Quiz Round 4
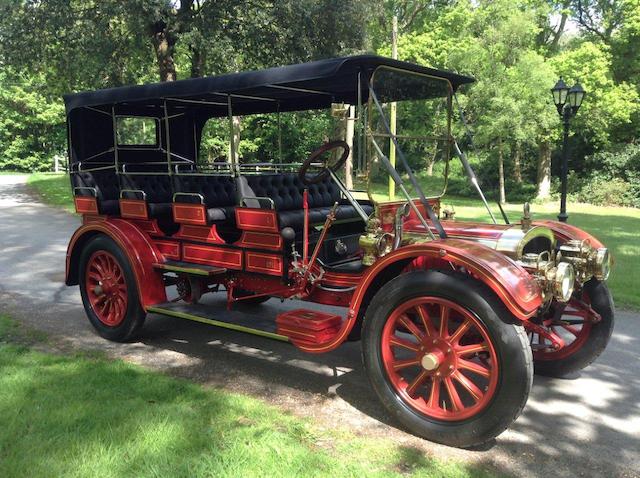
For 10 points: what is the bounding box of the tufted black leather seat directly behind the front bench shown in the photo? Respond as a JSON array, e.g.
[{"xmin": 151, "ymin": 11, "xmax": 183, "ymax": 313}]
[{"xmin": 174, "ymin": 174, "xmax": 237, "ymax": 225}]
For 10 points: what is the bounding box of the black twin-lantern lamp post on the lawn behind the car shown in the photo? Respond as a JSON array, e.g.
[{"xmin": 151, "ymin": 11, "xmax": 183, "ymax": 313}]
[{"xmin": 551, "ymin": 77, "xmax": 586, "ymax": 222}]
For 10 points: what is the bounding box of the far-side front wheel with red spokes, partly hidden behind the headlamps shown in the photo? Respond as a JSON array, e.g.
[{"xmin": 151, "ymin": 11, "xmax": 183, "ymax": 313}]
[{"xmin": 528, "ymin": 279, "xmax": 614, "ymax": 377}]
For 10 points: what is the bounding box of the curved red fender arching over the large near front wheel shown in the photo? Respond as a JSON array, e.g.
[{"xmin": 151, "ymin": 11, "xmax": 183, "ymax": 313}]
[{"xmin": 300, "ymin": 239, "xmax": 543, "ymax": 353}]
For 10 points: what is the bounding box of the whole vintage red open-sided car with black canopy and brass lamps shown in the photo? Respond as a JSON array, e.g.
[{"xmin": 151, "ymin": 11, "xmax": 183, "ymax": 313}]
[{"xmin": 65, "ymin": 56, "xmax": 614, "ymax": 447}]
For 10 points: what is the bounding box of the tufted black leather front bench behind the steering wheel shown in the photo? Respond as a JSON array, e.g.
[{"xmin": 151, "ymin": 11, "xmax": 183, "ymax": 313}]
[{"xmin": 243, "ymin": 173, "xmax": 373, "ymax": 230}]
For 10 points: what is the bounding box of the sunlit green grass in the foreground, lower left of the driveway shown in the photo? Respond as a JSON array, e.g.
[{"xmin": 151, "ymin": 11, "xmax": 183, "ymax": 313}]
[{"xmin": 0, "ymin": 316, "xmax": 491, "ymax": 477}]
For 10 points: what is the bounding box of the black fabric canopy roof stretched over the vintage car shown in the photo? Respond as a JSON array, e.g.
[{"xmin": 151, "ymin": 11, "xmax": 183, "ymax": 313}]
[{"xmin": 64, "ymin": 55, "xmax": 474, "ymax": 116}]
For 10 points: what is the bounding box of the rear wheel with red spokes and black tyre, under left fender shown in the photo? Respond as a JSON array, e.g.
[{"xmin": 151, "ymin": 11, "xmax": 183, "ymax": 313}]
[{"xmin": 78, "ymin": 235, "xmax": 146, "ymax": 342}]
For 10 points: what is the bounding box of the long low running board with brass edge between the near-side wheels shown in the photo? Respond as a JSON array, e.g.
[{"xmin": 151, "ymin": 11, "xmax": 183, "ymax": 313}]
[{"xmin": 147, "ymin": 302, "xmax": 289, "ymax": 342}]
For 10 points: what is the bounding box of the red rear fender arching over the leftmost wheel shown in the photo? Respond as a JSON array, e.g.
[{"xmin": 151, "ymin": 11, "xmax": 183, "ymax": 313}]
[{"xmin": 65, "ymin": 219, "xmax": 167, "ymax": 309}]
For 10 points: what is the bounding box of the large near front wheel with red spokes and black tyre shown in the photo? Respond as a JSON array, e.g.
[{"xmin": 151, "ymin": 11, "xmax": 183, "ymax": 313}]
[{"xmin": 363, "ymin": 271, "xmax": 533, "ymax": 447}]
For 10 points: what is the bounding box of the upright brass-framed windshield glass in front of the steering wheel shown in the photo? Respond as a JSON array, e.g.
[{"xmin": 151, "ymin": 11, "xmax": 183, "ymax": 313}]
[{"xmin": 367, "ymin": 68, "xmax": 451, "ymax": 201}]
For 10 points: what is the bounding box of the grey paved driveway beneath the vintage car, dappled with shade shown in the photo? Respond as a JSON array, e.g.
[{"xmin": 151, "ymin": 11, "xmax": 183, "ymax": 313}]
[{"xmin": 0, "ymin": 175, "xmax": 640, "ymax": 477}]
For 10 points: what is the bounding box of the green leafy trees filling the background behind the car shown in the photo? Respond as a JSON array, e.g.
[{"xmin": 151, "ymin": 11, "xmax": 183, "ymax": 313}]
[{"xmin": 0, "ymin": 0, "xmax": 640, "ymax": 204}]
